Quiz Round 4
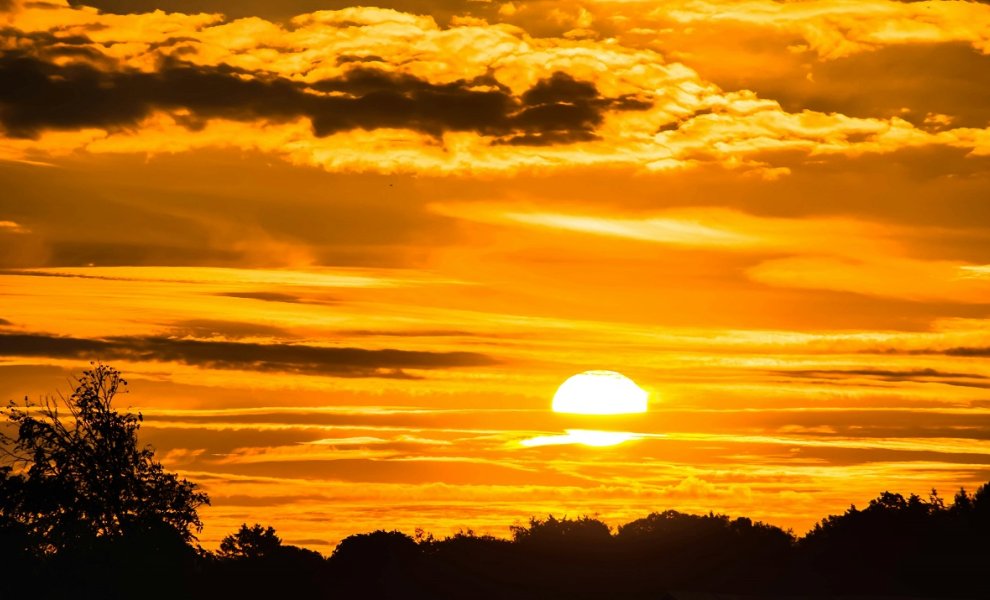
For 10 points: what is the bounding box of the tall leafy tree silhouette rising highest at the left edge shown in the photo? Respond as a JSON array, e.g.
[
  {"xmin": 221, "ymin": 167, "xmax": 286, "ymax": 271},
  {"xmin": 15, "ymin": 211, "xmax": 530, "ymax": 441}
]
[{"xmin": 0, "ymin": 364, "xmax": 209, "ymax": 554}]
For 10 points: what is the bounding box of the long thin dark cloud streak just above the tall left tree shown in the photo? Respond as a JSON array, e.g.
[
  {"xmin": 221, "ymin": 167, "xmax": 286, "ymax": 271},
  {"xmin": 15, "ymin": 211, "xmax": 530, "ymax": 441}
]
[{"xmin": 0, "ymin": 334, "xmax": 495, "ymax": 378}]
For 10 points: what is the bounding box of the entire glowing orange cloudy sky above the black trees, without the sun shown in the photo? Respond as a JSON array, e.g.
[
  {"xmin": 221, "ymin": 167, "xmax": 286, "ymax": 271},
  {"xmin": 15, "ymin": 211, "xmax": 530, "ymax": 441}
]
[{"xmin": 0, "ymin": 0, "xmax": 990, "ymax": 553}]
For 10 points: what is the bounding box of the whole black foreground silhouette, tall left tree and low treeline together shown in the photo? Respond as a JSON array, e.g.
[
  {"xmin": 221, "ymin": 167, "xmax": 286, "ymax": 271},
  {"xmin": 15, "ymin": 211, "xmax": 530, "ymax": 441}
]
[{"xmin": 0, "ymin": 365, "xmax": 990, "ymax": 600}]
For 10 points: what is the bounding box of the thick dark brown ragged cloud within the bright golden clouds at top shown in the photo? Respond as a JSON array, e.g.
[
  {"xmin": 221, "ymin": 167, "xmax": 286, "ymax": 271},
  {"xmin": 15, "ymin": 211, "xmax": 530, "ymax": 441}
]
[{"xmin": 0, "ymin": 53, "xmax": 649, "ymax": 145}]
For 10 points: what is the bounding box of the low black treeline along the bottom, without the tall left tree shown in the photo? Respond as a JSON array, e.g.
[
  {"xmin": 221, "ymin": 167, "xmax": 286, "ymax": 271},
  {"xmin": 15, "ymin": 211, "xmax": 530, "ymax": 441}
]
[{"xmin": 0, "ymin": 492, "xmax": 990, "ymax": 600}]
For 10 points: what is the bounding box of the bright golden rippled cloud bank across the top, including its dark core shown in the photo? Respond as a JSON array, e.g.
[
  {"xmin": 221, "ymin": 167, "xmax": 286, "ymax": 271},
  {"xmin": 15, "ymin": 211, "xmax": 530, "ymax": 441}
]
[{"xmin": 0, "ymin": 2, "xmax": 990, "ymax": 173}]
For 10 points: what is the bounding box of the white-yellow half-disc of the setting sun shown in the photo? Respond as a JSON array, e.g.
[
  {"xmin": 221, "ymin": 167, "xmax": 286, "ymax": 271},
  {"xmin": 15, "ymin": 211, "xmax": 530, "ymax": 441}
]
[{"xmin": 553, "ymin": 371, "xmax": 649, "ymax": 415}]
